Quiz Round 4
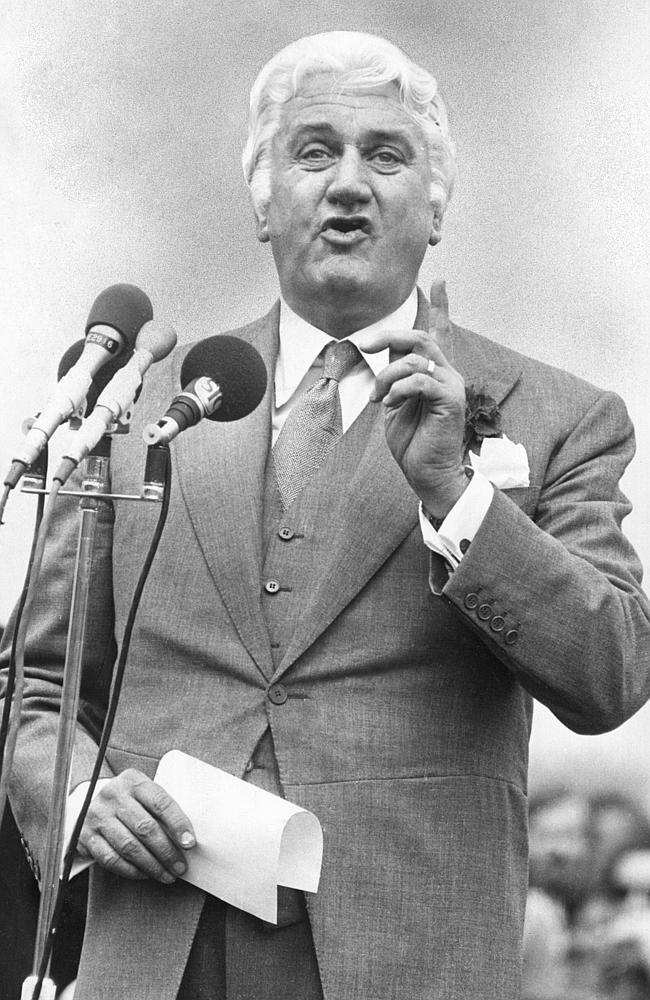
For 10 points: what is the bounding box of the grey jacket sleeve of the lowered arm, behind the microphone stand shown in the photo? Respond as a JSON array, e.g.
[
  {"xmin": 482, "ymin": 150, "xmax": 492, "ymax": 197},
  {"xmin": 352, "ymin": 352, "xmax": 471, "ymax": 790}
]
[{"xmin": 0, "ymin": 484, "xmax": 115, "ymax": 860}]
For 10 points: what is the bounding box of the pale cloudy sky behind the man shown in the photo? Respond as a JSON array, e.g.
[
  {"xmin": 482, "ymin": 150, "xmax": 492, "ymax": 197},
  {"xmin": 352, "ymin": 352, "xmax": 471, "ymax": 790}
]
[{"xmin": 0, "ymin": 0, "xmax": 650, "ymax": 805}]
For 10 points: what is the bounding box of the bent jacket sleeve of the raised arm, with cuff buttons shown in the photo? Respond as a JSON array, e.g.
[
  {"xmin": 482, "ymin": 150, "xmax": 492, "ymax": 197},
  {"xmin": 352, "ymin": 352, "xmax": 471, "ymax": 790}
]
[{"xmin": 442, "ymin": 393, "xmax": 650, "ymax": 733}]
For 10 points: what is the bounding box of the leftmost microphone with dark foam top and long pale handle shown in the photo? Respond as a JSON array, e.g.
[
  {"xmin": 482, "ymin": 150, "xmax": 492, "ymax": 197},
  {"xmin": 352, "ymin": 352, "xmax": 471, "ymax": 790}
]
[{"xmin": 5, "ymin": 284, "xmax": 153, "ymax": 488}]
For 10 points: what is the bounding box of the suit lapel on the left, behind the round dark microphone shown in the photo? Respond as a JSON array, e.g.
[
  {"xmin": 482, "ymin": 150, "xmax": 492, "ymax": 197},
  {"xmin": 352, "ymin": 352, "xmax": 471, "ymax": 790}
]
[{"xmin": 176, "ymin": 306, "xmax": 279, "ymax": 678}]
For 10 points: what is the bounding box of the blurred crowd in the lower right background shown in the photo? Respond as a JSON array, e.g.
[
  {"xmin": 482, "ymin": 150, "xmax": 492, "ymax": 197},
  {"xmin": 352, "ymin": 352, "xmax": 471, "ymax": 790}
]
[{"xmin": 522, "ymin": 789, "xmax": 650, "ymax": 1000}]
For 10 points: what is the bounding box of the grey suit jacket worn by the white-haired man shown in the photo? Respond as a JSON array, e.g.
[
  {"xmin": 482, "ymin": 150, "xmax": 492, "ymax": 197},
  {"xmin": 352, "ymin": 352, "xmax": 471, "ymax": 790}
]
[{"xmin": 1, "ymin": 292, "xmax": 650, "ymax": 1000}]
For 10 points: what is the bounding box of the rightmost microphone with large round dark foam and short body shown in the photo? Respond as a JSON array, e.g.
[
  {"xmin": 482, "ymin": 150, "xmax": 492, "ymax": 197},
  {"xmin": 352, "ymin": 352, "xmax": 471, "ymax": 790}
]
[{"xmin": 142, "ymin": 334, "xmax": 267, "ymax": 445}]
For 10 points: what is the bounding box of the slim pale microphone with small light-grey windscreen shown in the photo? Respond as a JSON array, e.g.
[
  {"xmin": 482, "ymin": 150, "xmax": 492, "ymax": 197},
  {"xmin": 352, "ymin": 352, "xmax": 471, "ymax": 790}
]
[{"xmin": 53, "ymin": 322, "xmax": 176, "ymax": 484}]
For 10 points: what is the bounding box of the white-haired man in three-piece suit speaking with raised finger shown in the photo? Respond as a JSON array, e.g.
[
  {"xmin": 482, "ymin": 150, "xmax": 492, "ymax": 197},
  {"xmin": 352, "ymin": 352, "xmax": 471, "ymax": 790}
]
[{"xmin": 3, "ymin": 32, "xmax": 649, "ymax": 1000}]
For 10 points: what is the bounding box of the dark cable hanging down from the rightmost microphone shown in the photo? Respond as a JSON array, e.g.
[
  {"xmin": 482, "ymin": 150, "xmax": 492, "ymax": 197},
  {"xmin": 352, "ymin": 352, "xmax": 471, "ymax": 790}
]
[{"xmin": 32, "ymin": 445, "xmax": 171, "ymax": 1000}]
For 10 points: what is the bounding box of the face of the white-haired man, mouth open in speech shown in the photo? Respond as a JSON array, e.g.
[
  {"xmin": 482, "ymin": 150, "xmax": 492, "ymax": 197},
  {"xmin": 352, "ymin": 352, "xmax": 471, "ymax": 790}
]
[{"xmin": 253, "ymin": 74, "xmax": 440, "ymax": 326}]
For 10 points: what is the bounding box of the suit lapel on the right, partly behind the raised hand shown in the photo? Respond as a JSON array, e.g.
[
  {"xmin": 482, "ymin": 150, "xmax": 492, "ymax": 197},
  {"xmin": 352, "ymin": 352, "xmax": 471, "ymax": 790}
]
[{"xmin": 275, "ymin": 290, "xmax": 521, "ymax": 678}]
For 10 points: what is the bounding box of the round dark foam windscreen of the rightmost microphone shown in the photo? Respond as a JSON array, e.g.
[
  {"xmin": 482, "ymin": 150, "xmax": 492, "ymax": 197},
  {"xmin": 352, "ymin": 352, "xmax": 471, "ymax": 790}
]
[{"xmin": 181, "ymin": 334, "xmax": 266, "ymax": 421}]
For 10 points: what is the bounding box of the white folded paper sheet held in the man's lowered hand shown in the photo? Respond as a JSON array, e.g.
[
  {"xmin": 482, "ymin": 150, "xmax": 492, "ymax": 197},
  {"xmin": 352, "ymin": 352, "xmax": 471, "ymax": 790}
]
[{"xmin": 155, "ymin": 750, "xmax": 323, "ymax": 923}]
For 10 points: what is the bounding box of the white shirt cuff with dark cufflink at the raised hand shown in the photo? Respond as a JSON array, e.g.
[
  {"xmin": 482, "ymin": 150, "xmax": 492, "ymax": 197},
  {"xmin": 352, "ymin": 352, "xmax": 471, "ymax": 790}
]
[{"xmin": 420, "ymin": 472, "xmax": 494, "ymax": 569}]
